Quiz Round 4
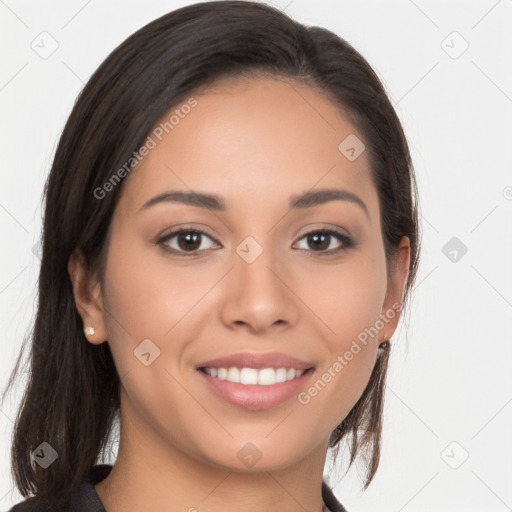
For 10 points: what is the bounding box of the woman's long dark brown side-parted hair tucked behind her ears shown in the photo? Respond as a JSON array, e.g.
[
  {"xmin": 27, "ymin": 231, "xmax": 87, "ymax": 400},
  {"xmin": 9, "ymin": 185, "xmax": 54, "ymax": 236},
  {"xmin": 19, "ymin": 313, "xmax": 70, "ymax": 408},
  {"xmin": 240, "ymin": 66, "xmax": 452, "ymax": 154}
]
[{"xmin": 4, "ymin": 1, "xmax": 419, "ymax": 506}]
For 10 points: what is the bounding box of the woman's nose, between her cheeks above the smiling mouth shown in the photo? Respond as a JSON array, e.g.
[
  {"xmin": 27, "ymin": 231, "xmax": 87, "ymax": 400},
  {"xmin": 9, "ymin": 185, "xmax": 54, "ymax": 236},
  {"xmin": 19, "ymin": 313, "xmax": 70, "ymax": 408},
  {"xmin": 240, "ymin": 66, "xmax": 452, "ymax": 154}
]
[{"xmin": 221, "ymin": 242, "xmax": 299, "ymax": 333}]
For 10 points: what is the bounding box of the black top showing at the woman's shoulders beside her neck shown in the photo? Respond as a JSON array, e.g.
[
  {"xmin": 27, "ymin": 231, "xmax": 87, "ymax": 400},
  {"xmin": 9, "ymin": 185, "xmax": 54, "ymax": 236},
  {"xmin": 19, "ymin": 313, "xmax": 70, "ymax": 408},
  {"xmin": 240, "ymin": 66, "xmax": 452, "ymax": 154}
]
[{"xmin": 8, "ymin": 464, "xmax": 347, "ymax": 512}]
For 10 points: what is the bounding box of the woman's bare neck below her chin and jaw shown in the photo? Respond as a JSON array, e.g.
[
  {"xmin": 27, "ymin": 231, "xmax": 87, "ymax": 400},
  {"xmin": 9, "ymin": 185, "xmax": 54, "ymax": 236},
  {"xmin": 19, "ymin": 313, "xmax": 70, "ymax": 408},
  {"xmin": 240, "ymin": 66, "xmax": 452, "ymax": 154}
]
[{"xmin": 95, "ymin": 410, "xmax": 327, "ymax": 512}]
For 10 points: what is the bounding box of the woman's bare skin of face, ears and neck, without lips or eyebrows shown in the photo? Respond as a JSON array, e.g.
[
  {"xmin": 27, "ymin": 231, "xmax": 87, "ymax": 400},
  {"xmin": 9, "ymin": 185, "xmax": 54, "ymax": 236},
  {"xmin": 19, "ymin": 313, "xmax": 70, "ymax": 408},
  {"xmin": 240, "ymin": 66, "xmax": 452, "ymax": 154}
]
[{"xmin": 69, "ymin": 78, "xmax": 410, "ymax": 512}]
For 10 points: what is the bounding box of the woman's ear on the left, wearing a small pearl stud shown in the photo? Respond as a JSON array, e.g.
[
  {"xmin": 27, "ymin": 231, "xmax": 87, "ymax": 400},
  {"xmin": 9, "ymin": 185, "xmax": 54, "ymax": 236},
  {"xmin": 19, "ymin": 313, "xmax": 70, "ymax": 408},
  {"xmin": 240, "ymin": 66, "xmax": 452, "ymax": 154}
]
[{"xmin": 68, "ymin": 250, "xmax": 108, "ymax": 344}]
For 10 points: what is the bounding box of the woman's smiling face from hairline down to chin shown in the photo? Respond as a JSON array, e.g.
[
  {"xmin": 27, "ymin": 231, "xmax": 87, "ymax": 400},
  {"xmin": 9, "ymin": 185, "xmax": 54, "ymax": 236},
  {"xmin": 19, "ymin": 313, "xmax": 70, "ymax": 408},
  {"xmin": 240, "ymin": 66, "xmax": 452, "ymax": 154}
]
[{"xmin": 72, "ymin": 78, "xmax": 408, "ymax": 471}]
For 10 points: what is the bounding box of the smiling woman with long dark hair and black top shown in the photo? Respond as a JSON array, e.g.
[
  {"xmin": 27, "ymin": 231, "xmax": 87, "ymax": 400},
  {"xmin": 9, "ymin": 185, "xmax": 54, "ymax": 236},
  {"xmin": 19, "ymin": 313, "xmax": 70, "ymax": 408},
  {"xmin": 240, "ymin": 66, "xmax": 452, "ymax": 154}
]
[{"xmin": 5, "ymin": 1, "xmax": 419, "ymax": 512}]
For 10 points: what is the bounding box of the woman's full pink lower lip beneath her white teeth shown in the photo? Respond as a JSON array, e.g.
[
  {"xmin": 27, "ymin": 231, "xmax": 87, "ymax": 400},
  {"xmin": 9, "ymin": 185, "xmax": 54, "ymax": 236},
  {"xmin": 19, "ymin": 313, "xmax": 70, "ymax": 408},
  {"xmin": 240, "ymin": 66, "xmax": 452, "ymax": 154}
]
[{"xmin": 197, "ymin": 369, "xmax": 313, "ymax": 411}]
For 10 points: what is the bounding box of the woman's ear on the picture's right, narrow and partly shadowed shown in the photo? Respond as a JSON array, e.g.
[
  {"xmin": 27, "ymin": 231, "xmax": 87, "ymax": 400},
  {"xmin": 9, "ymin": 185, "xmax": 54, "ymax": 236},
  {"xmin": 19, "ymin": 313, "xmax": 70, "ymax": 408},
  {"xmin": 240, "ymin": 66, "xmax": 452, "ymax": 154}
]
[{"xmin": 379, "ymin": 236, "xmax": 411, "ymax": 345}]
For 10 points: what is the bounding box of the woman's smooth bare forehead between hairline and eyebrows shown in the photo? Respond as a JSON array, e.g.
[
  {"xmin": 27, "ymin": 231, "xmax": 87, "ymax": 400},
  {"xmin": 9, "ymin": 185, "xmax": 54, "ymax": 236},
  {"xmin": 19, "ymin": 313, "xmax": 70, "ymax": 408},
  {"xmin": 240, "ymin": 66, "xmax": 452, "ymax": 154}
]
[{"xmin": 121, "ymin": 78, "xmax": 376, "ymax": 217}]
